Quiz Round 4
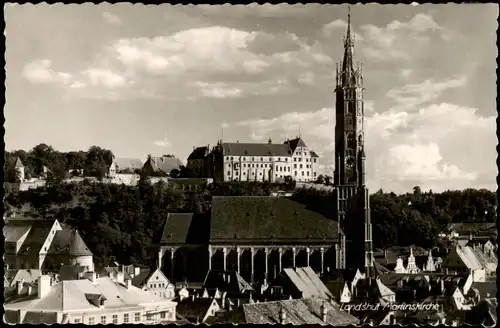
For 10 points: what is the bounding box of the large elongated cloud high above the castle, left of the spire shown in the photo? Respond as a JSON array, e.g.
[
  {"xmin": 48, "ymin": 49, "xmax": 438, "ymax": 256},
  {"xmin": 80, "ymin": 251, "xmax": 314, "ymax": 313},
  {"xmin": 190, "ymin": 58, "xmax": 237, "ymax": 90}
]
[{"xmin": 53, "ymin": 26, "xmax": 333, "ymax": 99}]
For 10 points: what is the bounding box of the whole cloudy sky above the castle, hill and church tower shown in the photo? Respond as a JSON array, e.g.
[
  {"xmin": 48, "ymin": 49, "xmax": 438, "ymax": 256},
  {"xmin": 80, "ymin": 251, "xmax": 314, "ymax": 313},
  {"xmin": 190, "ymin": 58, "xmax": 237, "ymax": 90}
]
[{"xmin": 4, "ymin": 3, "xmax": 498, "ymax": 193}]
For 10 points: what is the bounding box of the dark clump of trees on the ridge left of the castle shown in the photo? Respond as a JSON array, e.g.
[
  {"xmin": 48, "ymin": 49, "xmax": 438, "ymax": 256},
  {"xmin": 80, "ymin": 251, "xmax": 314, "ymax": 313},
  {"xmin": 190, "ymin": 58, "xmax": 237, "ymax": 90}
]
[{"xmin": 3, "ymin": 143, "xmax": 113, "ymax": 182}]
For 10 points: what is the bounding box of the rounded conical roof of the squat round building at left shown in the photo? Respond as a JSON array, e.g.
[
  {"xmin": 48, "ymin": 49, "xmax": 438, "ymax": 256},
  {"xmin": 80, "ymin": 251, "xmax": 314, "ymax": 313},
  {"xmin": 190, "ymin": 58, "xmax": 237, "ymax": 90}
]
[{"xmin": 47, "ymin": 230, "xmax": 92, "ymax": 256}]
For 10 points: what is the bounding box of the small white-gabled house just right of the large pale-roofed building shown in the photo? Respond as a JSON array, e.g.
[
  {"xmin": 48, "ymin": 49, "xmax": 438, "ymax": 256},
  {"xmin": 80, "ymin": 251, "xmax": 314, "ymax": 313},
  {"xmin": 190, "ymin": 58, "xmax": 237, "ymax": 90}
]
[{"xmin": 132, "ymin": 269, "xmax": 175, "ymax": 299}]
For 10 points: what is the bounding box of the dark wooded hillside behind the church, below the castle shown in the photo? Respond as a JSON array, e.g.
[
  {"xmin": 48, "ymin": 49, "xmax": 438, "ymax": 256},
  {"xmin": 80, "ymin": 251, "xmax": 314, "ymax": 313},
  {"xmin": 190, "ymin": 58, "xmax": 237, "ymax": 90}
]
[{"xmin": 6, "ymin": 174, "xmax": 496, "ymax": 270}]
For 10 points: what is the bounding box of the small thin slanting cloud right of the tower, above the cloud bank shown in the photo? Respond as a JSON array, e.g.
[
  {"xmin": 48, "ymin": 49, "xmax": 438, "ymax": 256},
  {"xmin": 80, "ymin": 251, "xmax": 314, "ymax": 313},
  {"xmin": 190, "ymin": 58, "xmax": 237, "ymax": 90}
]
[{"xmin": 386, "ymin": 77, "xmax": 467, "ymax": 108}]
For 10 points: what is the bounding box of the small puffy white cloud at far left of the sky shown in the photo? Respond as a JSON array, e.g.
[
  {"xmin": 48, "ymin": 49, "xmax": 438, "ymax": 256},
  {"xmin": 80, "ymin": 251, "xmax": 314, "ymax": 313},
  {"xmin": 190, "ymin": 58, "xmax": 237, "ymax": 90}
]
[{"xmin": 21, "ymin": 59, "xmax": 72, "ymax": 84}]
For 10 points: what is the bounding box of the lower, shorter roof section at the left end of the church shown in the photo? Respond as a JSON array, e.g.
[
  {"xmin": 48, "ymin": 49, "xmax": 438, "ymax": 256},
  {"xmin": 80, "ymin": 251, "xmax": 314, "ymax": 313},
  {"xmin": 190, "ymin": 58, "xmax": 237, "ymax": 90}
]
[{"xmin": 160, "ymin": 213, "xmax": 210, "ymax": 244}]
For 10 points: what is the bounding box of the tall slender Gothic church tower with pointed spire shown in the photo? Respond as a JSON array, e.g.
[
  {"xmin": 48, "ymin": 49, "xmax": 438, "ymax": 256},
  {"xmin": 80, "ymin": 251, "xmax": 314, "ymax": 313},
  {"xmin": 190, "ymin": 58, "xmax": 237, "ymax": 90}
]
[{"xmin": 334, "ymin": 7, "xmax": 373, "ymax": 276}]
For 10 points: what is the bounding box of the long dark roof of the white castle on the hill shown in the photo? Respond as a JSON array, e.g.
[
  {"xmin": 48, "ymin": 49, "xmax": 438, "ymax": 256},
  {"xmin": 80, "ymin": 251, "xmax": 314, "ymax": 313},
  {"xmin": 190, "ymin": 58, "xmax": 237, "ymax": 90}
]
[{"xmin": 222, "ymin": 142, "xmax": 291, "ymax": 157}]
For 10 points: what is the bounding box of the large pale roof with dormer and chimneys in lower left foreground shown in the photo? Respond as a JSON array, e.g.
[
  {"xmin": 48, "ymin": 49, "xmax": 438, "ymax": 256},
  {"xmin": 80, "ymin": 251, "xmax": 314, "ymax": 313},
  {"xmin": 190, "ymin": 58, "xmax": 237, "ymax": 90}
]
[{"xmin": 4, "ymin": 278, "xmax": 174, "ymax": 312}]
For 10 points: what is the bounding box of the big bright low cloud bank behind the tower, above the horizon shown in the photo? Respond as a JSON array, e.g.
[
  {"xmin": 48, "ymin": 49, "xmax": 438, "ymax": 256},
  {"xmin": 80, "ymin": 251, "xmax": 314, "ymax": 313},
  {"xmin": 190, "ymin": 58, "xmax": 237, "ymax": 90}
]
[{"xmin": 233, "ymin": 103, "xmax": 496, "ymax": 192}]
